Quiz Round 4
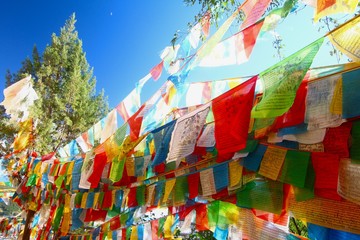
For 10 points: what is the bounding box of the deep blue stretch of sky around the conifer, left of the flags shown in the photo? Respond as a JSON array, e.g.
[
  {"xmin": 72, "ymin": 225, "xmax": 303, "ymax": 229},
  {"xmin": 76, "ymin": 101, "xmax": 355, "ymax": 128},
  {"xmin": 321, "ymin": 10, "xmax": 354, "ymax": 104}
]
[{"xmin": 0, "ymin": 0, "xmax": 198, "ymax": 107}]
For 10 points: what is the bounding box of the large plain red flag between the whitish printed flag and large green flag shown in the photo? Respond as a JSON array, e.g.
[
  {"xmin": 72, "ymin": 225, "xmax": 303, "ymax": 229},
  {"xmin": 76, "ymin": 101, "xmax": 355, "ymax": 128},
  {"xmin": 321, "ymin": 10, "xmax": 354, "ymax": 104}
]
[{"xmin": 212, "ymin": 76, "xmax": 257, "ymax": 155}]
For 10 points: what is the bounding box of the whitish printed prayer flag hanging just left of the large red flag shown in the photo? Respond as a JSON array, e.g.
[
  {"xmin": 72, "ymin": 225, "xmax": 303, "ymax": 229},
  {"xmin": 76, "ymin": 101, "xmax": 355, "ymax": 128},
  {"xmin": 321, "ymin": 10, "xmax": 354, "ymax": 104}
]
[{"xmin": 166, "ymin": 103, "xmax": 210, "ymax": 166}]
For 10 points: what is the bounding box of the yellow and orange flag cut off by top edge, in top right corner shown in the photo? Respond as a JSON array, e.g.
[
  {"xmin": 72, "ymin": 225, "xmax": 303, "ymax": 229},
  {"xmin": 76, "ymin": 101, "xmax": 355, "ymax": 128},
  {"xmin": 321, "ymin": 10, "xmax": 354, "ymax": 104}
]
[{"xmin": 314, "ymin": 0, "xmax": 358, "ymax": 22}]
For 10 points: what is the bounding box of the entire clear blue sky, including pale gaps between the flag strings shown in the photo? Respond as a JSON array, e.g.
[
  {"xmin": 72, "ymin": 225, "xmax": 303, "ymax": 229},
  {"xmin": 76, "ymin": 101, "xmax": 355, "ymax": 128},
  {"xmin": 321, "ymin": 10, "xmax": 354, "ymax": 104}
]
[{"xmin": 0, "ymin": 0, "xmax": 348, "ymax": 108}]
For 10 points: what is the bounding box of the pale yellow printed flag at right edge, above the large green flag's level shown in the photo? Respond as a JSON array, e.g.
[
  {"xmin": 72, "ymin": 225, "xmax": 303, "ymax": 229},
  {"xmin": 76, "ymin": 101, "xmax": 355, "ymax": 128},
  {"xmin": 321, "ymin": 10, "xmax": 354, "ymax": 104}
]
[{"xmin": 328, "ymin": 15, "xmax": 360, "ymax": 62}]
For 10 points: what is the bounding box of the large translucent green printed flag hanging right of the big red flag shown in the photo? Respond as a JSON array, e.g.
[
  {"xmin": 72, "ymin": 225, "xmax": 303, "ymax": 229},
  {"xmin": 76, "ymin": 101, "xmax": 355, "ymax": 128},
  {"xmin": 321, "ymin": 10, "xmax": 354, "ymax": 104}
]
[{"xmin": 251, "ymin": 38, "xmax": 324, "ymax": 118}]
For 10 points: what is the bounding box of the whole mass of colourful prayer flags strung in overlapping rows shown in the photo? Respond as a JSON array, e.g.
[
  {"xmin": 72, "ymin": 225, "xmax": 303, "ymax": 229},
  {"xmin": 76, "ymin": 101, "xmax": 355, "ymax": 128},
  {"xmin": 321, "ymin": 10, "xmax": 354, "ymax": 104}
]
[{"xmin": 0, "ymin": 0, "xmax": 360, "ymax": 239}]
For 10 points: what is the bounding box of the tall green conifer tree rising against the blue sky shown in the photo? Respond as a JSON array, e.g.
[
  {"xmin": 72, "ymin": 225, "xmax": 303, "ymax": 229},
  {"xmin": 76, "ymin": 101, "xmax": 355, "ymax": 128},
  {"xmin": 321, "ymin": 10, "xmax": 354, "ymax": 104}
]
[{"xmin": 28, "ymin": 14, "xmax": 108, "ymax": 154}]
